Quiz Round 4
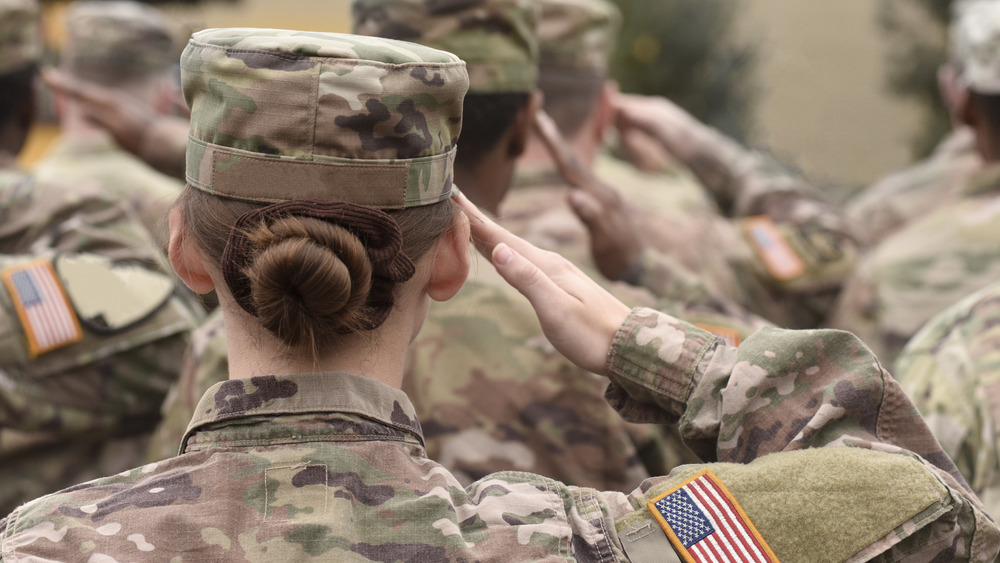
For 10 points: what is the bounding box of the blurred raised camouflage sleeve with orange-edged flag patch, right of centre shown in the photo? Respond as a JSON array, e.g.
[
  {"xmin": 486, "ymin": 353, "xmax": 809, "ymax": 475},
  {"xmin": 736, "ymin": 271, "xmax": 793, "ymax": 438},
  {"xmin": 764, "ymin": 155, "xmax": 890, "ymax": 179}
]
[{"xmin": 664, "ymin": 123, "xmax": 858, "ymax": 328}]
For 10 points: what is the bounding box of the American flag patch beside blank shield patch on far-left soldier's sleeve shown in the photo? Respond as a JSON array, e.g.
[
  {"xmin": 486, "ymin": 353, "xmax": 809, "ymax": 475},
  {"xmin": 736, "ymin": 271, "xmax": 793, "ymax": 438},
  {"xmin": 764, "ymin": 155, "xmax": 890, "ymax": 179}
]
[{"xmin": 2, "ymin": 259, "xmax": 83, "ymax": 358}]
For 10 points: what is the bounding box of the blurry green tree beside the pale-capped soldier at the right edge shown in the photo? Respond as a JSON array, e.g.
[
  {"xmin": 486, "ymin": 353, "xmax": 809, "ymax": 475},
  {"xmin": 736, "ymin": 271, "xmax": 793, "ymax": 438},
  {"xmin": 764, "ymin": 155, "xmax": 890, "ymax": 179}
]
[{"xmin": 878, "ymin": 0, "xmax": 952, "ymax": 158}]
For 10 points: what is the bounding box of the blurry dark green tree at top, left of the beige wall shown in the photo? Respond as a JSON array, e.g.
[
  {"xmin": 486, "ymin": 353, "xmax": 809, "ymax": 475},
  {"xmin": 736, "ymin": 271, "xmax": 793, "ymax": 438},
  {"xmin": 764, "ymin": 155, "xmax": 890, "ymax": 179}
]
[{"xmin": 612, "ymin": 0, "xmax": 757, "ymax": 139}]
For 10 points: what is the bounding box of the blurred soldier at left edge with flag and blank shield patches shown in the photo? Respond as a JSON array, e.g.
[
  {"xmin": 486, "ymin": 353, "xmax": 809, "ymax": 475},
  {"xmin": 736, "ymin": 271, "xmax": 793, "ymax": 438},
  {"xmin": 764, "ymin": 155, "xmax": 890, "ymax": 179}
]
[{"xmin": 0, "ymin": 0, "xmax": 197, "ymax": 511}]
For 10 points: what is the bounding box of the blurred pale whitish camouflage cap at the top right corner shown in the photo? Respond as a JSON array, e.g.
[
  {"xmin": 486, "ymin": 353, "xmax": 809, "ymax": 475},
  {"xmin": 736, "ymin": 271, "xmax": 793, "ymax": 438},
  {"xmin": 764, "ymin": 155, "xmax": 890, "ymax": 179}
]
[{"xmin": 951, "ymin": 0, "xmax": 1000, "ymax": 94}]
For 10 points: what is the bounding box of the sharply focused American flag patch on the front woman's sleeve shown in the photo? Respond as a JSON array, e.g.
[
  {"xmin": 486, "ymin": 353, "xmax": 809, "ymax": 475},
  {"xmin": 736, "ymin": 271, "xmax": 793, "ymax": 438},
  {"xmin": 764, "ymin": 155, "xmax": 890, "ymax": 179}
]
[{"xmin": 646, "ymin": 469, "xmax": 778, "ymax": 563}]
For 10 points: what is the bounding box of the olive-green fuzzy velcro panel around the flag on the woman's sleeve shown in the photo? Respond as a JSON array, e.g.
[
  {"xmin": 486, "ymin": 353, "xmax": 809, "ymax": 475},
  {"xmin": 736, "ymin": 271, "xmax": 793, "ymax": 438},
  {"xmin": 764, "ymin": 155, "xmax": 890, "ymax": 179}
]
[{"xmin": 616, "ymin": 447, "xmax": 952, "ymax": 562}]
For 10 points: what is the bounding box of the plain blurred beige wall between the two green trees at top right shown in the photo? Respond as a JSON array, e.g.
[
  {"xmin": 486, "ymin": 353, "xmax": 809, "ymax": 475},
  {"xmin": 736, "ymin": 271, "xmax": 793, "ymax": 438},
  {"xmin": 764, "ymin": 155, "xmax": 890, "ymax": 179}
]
[{"xmin": 743, "ymin": 0, "xmax": 920, "ymax": 189}]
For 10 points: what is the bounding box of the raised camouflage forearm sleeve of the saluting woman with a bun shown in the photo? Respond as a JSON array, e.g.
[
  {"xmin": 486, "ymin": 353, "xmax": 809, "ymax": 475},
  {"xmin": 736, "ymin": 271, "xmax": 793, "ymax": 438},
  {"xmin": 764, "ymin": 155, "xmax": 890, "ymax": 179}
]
[{"xmin": 607, "ymin": 309, "xmax": 967, "ymax": 488}]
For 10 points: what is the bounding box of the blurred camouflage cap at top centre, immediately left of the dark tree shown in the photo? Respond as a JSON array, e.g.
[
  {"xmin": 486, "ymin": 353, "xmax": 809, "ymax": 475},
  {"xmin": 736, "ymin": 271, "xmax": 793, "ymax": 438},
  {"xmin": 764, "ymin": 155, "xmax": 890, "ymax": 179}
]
[{"xmin": 538, "ymin": 0, "xmax": 622, "ymax": 77}]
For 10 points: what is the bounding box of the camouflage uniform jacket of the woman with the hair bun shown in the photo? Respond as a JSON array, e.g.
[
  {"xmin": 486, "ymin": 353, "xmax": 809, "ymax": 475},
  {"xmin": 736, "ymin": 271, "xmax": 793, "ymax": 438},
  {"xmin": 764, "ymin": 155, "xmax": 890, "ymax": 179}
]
[{"xmin": 0, "ymin": 309, "xmax": 1000, "ymax": 562}]
